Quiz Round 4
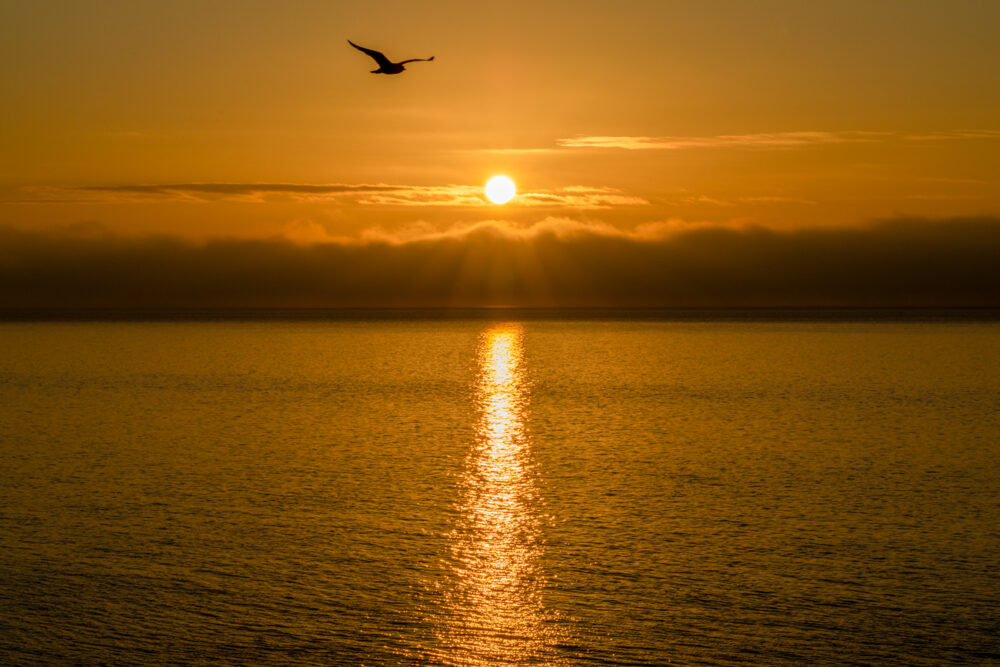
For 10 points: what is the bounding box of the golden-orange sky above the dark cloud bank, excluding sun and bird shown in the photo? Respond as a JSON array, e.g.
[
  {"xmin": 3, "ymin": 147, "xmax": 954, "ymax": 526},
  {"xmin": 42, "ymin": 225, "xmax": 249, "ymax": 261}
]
[{"xmin": 0, "ymin": 0, "xmax": 1000, "ymax": 306}]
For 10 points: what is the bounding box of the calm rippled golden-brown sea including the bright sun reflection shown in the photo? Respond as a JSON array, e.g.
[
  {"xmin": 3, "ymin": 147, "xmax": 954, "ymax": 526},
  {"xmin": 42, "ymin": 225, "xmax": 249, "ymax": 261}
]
[{"xmin": 0, "ymin": 318, "xmax": 1000, "ymax": 665}]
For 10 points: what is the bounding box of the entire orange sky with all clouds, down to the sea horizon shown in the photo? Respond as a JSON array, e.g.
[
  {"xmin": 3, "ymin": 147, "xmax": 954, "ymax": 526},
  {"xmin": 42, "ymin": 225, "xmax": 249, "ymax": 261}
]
[{"xmin": 0, "ymin": 0, "xmax": 1000, "ymax": 307}]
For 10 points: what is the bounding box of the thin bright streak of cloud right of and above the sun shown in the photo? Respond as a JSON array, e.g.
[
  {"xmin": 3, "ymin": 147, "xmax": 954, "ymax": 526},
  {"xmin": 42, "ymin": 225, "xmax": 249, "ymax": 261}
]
[{"xmin": 556, "ymin": 130, "xmax": 1000, "ymax": 150}]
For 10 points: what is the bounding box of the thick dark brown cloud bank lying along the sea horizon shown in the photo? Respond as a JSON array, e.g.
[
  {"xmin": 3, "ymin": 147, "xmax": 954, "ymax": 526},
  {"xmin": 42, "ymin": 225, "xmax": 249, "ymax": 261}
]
[{"xmin": 0, "ymin": 217, "xmax": 1000, "ymax": 309}]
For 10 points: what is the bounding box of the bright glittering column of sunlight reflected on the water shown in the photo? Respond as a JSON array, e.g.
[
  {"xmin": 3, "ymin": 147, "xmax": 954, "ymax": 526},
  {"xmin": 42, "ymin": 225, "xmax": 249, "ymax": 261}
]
[{"xmin": 441, "ymin": 324, "xmax": 557, "ymax": 664}]
